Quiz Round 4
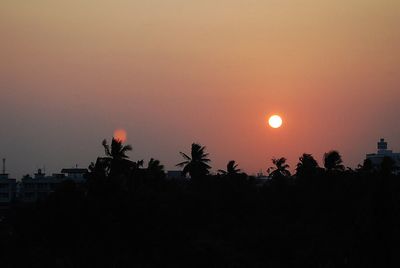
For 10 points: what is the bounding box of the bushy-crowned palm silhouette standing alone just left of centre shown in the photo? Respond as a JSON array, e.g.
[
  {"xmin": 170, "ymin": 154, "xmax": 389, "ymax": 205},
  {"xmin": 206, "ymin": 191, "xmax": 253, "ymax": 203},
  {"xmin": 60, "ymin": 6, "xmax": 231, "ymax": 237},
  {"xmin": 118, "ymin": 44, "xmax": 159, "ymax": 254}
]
[{"xmin": 176, "ymin": 143, "xmax": 211, "ymax": 179}]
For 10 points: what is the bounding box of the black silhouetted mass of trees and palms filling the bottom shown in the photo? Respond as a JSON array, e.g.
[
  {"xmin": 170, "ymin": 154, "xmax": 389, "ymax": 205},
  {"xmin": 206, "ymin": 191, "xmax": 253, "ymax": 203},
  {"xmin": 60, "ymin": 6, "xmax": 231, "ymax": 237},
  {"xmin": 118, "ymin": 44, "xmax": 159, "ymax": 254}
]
[{"xmin": 0, "ymin": 141, "xmax": 400, "ymax": 267}]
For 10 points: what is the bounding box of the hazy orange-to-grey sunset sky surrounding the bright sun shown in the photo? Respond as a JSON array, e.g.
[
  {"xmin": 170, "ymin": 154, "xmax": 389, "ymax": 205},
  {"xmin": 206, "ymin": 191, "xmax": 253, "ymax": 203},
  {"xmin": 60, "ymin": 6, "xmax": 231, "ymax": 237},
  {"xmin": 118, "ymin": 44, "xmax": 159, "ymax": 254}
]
[{"xmin": 0, "ymin": 0, "xmax": 400, "ymax": 178}]
